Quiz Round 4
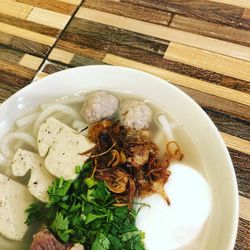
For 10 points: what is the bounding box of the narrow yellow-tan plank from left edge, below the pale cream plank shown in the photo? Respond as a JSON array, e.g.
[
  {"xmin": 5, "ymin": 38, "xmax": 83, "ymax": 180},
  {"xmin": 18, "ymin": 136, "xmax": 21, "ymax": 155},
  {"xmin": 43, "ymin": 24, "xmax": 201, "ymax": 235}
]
[{"xmin": 0, "ymin": 22, "xmax": 56, "ymax": 46}]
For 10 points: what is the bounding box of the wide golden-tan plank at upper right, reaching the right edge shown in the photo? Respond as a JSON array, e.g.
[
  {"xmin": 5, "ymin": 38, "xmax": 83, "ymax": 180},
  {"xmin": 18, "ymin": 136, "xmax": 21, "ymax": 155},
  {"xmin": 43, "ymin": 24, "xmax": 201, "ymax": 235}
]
[{"xmin": 164, "ymin": 43, "xmax": 250, "ymax": 81}]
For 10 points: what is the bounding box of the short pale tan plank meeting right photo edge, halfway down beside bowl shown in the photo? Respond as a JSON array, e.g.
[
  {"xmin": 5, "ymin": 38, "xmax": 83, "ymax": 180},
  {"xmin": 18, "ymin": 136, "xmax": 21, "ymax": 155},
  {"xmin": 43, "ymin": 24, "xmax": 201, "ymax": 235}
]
[{"xmin": 221, "ymin": 132, "xmax": 250, "ymax": 155}]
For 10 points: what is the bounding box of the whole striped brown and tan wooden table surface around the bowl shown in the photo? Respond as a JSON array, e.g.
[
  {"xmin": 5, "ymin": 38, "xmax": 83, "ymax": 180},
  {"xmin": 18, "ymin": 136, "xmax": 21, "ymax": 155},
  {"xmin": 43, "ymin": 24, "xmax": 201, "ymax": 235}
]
[{"xmin": 0, "ymin": 0, "xmax": 250, "ymax": 250}]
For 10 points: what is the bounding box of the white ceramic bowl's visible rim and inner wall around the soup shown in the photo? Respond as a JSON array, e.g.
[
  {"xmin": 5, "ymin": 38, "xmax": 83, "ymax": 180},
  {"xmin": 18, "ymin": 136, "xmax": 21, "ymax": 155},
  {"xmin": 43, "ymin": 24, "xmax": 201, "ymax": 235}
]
[{"xmin": 0, "ymin": 66, "xmax": 239, "ymax": 250}]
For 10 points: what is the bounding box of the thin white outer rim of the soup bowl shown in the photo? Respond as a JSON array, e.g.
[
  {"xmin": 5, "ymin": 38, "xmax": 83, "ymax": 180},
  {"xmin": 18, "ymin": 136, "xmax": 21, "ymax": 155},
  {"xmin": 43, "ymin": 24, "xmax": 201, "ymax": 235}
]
[{"xmin": 0, "ymin": 65, "xmax": 239, "ymax": 249}]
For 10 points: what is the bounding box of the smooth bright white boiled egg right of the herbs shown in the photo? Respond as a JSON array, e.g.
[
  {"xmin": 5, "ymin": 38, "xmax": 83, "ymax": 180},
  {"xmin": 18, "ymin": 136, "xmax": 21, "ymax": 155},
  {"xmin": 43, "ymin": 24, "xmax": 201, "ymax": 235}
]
[{"xmin": 136, "ymin": 164, "xmax": 212, "ymax": 250}]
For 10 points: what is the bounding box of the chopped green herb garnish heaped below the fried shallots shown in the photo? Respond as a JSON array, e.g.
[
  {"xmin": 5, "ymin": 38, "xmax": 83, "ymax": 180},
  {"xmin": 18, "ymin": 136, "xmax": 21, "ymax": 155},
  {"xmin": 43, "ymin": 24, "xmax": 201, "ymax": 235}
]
[{"xmin": 26, "ymin": 162, "xmax": 145, "ymax": 250}]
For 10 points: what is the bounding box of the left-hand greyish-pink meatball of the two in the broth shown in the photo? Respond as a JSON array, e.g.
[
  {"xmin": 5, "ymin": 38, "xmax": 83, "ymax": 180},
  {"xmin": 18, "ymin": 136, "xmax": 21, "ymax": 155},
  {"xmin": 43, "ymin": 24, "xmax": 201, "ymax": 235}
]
[{"xmin": 81, "ymin": 91, "xmax": 119, "ymax": 123}]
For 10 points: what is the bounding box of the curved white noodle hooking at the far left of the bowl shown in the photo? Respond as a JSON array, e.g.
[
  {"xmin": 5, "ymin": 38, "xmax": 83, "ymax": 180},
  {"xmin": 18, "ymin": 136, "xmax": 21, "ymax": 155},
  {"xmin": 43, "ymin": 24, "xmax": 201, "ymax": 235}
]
[{"xmin": 0, "ymin": 132, "xmax": 37, "ymax": 157}]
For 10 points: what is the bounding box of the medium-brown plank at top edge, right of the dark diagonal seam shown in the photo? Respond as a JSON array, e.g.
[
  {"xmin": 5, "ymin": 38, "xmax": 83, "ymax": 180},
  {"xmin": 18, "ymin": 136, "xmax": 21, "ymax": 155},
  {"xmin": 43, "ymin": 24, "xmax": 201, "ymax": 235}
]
[{"xmin": 83, "ymin": 0, "xmax": 171, "ymax": 26}]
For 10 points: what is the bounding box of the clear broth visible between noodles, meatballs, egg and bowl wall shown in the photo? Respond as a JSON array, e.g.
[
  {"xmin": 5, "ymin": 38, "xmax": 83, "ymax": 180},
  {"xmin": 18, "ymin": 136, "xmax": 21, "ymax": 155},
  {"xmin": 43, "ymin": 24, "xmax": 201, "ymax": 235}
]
[{"xmin": 0, "ymin": 92, "xmax": 207, "ymax": 250}]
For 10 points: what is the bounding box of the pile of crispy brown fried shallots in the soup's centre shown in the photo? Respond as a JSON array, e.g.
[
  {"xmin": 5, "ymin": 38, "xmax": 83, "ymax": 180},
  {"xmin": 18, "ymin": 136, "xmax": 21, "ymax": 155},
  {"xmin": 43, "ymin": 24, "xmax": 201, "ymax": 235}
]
[{"xmin": 82, "ymin": 120, "xmax": 183, "ymax": 207}]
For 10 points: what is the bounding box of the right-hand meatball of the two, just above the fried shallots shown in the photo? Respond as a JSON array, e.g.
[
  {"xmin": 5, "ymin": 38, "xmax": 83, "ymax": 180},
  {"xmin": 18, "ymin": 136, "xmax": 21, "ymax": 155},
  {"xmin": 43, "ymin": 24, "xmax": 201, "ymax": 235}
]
[{"xmin": 120, "ymin": 100, "xmax": 152, "ymax": 130}]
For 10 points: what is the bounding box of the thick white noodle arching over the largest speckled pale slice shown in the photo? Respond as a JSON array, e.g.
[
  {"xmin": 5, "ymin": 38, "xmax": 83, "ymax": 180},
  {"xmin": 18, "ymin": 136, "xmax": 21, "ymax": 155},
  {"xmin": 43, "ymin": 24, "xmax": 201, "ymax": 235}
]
[{"xmin": 34, "ymin": 104, "xmax": 81, "ymax": 133}]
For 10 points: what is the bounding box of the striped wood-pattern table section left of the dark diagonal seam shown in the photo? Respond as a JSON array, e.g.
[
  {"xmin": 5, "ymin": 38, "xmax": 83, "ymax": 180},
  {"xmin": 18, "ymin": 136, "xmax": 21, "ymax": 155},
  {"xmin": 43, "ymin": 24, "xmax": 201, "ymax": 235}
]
[{"xmin": 0, "ymin": 0, "xmax": 81, "ymax": 101}]
